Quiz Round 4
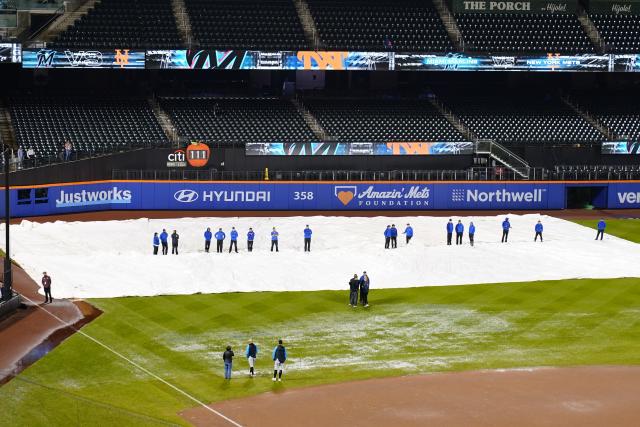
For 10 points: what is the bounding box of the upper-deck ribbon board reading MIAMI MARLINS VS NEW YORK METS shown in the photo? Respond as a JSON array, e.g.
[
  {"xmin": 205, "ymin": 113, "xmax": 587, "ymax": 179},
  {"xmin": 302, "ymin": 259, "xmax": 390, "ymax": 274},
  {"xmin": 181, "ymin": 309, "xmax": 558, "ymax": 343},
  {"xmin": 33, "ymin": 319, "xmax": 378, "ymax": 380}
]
[{"xmin": 394, "ymin": 53, "xmax": 611, "ymax": 71}]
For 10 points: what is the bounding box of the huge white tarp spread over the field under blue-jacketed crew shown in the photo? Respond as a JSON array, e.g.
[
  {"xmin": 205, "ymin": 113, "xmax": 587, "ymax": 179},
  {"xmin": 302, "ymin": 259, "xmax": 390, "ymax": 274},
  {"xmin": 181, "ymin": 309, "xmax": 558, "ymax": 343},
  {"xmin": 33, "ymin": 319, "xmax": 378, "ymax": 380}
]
[{"xmin": 0, "ymin": 214, "xmax": 640, "ymax": 298}]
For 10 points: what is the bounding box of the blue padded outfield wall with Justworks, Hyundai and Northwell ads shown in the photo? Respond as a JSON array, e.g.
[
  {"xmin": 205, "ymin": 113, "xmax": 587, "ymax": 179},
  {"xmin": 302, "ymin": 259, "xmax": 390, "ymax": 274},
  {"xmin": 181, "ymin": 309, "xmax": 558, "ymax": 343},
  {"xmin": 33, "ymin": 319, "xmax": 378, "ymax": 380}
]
[{"xmin": 7, "ymin": 181, "xmax": 640, "ymax": 217}]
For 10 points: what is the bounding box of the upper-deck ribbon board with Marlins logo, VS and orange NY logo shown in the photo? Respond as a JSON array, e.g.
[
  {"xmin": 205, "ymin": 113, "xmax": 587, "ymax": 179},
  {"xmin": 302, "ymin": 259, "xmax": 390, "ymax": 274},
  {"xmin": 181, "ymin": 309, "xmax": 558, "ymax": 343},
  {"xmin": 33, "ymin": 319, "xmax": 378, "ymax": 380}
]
[{"xmin": 22, "ymin": 49, "xmax": 145, "ymax": 69}]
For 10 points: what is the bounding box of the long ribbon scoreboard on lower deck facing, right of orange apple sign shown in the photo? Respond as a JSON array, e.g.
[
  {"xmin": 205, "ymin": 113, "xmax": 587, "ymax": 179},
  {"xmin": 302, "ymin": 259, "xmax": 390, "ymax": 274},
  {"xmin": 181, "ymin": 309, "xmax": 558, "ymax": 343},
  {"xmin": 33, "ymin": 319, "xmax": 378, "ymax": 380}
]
[{"xmin": 245, "ymin": 142, "xmax": 474, "ymax": 156}]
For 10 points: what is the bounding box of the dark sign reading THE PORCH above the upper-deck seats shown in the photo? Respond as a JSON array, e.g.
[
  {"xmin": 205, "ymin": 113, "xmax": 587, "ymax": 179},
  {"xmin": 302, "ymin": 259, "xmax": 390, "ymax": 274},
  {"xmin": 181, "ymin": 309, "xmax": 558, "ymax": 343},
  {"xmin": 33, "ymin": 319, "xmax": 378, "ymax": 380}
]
[{"xmin": 451, "ymin": 0, "xmax": 577, "ymax": 14}]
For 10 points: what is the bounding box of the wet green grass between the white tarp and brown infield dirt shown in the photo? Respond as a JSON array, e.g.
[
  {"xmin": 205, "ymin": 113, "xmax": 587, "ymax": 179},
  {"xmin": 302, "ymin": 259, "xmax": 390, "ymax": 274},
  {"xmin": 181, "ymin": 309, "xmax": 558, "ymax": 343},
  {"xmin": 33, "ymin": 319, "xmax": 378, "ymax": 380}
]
[{"xmin": 0, "ymin": 279, "xmax": 640, "ymax": 426}]
